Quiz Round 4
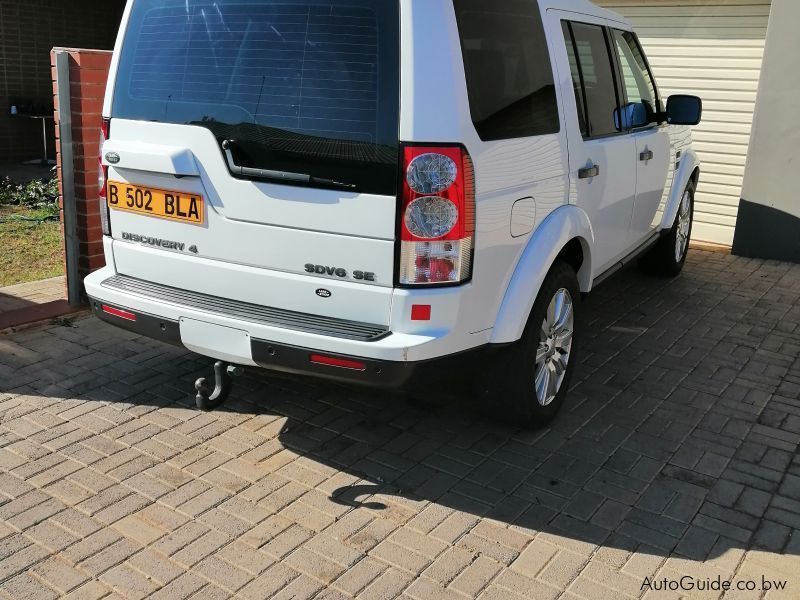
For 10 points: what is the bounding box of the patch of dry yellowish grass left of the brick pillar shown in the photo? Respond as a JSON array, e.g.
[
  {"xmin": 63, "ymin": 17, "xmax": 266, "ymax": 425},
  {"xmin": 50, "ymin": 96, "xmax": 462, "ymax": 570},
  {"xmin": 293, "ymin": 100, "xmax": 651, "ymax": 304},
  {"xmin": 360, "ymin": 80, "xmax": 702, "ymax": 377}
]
[{"xmin": 0, "ymin": 204, "xmax": 64, "ymax": 287}]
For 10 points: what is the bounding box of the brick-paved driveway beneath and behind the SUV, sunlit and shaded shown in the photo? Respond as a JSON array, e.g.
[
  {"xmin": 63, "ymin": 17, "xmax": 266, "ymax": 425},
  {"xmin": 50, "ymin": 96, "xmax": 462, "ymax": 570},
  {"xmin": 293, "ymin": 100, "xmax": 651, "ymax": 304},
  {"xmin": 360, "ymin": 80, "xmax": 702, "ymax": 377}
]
[{"xmin": 0, "ymin": 251, "xmax": 800, "ymax": 600}]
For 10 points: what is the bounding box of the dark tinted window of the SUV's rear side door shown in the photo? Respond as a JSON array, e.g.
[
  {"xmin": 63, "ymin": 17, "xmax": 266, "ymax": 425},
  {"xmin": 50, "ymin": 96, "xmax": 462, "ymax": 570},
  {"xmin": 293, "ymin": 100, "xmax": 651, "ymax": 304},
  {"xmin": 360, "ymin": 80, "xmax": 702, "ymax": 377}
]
[{"xmin": 562, "ymin": 21, "xmax": 624, "ymax": 137}]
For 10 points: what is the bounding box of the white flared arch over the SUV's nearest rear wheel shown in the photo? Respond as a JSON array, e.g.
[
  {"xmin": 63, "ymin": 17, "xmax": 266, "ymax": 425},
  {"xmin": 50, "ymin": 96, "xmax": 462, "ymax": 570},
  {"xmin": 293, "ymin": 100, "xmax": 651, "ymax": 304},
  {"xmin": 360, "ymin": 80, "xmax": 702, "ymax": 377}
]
[{"xmin": 490, "ymin": 204, "xmax": 594, "ymax": 344}]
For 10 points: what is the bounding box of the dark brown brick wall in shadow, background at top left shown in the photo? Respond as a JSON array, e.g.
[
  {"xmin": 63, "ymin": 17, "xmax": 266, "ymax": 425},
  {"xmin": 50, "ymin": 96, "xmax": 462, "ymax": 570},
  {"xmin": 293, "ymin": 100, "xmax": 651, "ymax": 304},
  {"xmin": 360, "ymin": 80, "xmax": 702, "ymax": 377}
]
[{"xmin": 0, "ymin": 0, "xmax": 125, "ymax": 164}]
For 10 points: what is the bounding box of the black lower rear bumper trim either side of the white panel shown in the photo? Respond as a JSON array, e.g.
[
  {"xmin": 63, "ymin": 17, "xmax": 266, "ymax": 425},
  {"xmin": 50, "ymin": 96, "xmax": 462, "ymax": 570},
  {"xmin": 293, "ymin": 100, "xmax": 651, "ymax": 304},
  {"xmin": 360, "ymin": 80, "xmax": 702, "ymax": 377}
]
[{"xmin": 90, "ymin": 296, "xmax": 490, "ymax": 389}]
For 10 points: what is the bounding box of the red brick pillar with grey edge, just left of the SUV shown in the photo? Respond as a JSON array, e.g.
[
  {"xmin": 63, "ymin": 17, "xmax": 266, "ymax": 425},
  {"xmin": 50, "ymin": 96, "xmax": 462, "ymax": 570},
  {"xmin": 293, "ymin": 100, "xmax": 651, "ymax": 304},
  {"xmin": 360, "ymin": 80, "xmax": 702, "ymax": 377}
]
[{"xmin": 51, "ymin": 48, "xmax": 111, "ymax": 281}]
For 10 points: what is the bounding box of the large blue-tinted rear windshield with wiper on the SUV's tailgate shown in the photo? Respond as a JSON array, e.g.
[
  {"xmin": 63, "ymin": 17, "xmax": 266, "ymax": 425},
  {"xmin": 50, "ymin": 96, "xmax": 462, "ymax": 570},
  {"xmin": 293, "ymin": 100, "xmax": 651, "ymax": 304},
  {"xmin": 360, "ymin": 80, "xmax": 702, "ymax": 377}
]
[{"xmin": 111, "ymin": 0, "xmax": 400, "ymax": 194}]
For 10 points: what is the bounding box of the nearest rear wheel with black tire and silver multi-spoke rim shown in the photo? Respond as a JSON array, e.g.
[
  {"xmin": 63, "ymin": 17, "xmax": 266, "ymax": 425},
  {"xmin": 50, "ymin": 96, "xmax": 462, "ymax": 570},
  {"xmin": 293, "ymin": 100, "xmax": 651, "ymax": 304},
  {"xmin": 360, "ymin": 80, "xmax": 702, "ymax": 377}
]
[{"xmin": 478, "ymin": 262, "xmax": 581, "ymax": 427}]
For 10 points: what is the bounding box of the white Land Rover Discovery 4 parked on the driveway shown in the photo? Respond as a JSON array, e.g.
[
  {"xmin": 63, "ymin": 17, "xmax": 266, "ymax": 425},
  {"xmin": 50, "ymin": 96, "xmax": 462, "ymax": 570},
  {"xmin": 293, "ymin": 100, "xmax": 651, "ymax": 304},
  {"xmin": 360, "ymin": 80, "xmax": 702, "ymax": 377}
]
[{"xmin": 85, "ymin": 0, "xmax": 701, "ymax": 424}]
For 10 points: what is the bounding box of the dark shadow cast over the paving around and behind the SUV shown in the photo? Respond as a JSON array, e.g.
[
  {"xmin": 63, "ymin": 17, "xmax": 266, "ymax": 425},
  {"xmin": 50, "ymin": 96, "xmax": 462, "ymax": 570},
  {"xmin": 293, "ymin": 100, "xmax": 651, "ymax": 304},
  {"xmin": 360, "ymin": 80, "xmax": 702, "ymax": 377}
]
[{"xmin": 0, "ymin": 252, "xmax": 800, "ymax": 560}]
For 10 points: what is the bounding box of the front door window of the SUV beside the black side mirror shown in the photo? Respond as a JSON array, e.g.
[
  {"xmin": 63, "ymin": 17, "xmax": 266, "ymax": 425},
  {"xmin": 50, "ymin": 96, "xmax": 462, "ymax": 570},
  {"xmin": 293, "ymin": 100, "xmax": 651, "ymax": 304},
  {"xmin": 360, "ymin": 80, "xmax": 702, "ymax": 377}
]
[{"xmin": 614, "ymin": 29, "xmax": 661, "ymax": 127}]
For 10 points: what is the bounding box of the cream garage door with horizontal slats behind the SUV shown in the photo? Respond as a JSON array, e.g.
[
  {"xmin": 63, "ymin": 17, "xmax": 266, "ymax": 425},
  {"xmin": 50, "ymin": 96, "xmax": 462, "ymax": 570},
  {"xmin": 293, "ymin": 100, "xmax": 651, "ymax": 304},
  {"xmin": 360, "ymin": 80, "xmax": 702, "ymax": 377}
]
[{"xmin": 595, "ymin": 0, "xmax": 770, "ymax": 245}]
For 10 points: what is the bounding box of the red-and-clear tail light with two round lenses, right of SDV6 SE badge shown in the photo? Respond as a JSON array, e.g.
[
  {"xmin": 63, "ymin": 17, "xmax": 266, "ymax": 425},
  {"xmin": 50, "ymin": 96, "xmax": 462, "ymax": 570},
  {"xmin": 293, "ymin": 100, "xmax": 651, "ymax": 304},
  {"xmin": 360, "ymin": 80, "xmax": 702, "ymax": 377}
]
[{"xmin": 398, "ymin": 146, "xmax": 475, "ymax": 286}]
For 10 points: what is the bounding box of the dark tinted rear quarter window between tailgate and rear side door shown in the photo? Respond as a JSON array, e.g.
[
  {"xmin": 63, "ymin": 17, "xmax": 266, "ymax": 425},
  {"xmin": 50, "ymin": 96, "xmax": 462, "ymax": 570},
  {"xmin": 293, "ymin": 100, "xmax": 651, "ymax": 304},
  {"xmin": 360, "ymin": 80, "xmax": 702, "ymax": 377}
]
[{"xmin": 454, "ymin": 0, "xmax": 560, "ymax": 140}]
